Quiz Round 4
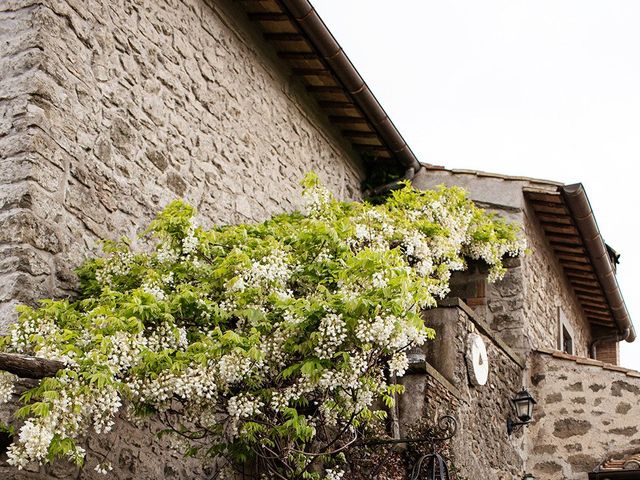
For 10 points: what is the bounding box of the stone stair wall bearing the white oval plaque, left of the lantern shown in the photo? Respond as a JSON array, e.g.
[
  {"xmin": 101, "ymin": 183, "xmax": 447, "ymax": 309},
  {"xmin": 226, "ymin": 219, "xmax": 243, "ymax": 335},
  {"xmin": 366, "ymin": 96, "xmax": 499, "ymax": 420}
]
[{"xmin": 399, "ymin": 300, "xmax": 524, "ymax": 480}]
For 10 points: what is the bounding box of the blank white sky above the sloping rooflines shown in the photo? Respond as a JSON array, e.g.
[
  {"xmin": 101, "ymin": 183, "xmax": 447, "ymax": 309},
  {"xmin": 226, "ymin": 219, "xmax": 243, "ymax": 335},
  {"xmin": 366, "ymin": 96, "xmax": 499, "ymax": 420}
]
[{"xmin": 312, "ymin": 0, "xmax": 640, "ymax": 370}]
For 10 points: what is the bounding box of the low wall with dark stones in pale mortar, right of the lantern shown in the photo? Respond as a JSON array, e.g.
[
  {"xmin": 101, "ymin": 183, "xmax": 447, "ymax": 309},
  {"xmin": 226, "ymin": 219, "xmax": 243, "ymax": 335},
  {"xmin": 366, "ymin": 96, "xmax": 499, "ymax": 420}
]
[{"xmin": 527, "ymin": 350, "xmax": 640, "ymax": 480}]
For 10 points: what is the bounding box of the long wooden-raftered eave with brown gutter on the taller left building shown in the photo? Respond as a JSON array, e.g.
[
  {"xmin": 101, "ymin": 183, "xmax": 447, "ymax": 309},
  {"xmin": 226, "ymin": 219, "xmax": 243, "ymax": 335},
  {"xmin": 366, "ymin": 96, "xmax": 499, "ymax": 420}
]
[{"xmin": 239, "ymin": 0, "xmax": 422, "ymax": 172}]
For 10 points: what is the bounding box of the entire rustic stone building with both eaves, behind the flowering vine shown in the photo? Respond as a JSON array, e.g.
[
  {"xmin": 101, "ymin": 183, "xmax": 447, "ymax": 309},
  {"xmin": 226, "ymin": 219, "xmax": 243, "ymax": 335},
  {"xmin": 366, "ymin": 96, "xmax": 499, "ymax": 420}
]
[{"xmin": 0, "ymin": 0, "xmax": 640, "ymax": 480}]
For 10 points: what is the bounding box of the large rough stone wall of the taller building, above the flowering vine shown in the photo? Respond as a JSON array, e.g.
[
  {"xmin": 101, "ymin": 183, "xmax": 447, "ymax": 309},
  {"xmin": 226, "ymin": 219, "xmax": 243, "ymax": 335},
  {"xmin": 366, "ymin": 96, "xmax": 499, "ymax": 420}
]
[{"xmin": 0, "ymin": 0, "xmax": 363, "ymax": 327}]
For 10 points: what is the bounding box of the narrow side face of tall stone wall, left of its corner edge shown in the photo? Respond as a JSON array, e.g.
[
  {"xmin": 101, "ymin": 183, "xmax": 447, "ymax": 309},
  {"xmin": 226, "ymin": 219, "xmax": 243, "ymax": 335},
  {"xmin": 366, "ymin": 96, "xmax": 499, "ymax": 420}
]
[{"xmin": 0, "ymin": 0, "xmax": 51, "ymax": 334}]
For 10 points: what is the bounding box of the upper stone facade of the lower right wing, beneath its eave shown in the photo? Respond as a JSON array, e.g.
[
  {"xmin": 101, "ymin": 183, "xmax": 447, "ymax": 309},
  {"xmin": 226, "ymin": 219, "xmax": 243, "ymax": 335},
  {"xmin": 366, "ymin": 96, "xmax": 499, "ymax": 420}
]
[{"xmin": 414, "ymin": 170, "xmax": 591, "ymax": 356}]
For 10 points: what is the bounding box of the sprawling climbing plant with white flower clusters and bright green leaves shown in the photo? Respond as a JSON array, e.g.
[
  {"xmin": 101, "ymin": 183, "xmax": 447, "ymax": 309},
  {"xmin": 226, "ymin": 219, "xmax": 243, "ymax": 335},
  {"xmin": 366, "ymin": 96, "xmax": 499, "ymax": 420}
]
[{"xmin": 0, "ymin": 175, "xmax": 523, "ymax": 479}]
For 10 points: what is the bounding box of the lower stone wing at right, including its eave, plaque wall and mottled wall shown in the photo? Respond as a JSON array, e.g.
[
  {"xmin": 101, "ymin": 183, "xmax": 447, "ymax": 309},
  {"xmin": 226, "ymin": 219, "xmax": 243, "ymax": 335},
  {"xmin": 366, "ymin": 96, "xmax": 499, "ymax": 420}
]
[{"xmin": 400, "ymin": 166, "xmax": 640, "ymax": 480}]
